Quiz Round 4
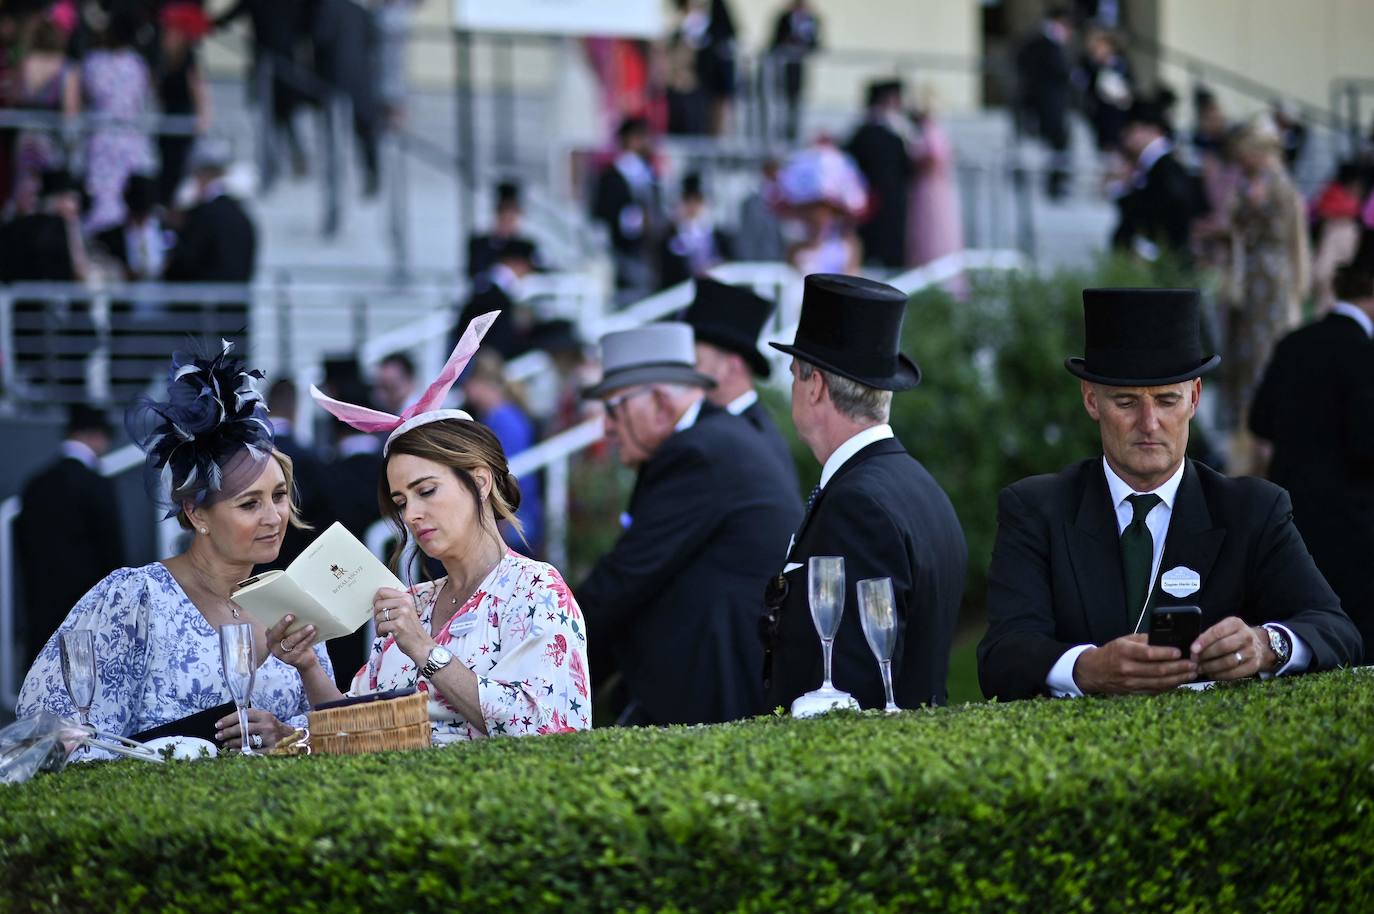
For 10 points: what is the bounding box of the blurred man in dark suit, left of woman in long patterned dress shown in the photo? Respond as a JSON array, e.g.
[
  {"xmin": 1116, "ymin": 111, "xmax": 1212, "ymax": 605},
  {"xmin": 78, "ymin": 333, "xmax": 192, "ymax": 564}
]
[{"xmin": 1112, "ymin": 102, "xmax": 1201, "ymax": 261}]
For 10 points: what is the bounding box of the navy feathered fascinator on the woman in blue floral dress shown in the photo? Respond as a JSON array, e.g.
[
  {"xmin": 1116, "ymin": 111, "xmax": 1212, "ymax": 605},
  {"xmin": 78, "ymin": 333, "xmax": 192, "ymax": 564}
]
[{"xmin": 124, "ymin": 339, "xmax": 272, "ymax": 517}]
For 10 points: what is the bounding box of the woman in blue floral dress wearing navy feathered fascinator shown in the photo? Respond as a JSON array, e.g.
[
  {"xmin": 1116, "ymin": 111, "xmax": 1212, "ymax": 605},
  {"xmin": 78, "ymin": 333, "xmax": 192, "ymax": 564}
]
[{"xmin": 15, "ymin": 344, "xmax": 331, "ymax": 748}]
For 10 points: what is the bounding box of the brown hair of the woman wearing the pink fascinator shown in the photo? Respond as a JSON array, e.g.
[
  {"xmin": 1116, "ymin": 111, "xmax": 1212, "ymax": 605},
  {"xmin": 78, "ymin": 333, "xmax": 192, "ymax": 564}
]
[{"xmin": 376, "ymin": 419, "xmax": 525, "ymax": 573}]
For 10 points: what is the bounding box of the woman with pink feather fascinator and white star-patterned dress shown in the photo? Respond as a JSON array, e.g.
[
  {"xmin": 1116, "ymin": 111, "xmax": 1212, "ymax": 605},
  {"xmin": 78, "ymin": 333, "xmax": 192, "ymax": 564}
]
[{"xmin": 268, "ymin": 312, "xmax": 591, "ymax": 745}]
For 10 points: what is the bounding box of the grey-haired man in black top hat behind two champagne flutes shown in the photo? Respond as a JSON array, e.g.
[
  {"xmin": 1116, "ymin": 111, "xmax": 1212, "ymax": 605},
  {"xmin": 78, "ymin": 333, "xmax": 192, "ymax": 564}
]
[{"xmin": 763, "ymin": 274, "xmax": 969, "ymax": 708}]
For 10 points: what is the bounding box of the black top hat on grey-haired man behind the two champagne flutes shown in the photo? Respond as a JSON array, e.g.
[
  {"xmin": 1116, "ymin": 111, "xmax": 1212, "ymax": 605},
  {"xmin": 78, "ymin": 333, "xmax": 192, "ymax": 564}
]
[{"xmin": 768, "ymin": 274, "xmax": 921, "ymax": 390}]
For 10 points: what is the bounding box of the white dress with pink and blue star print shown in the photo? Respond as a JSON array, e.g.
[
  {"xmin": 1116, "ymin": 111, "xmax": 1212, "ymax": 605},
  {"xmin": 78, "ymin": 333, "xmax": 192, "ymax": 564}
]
[{"xmin": 349, "ymin": 551, "xmax": 592, "ymax": 745}]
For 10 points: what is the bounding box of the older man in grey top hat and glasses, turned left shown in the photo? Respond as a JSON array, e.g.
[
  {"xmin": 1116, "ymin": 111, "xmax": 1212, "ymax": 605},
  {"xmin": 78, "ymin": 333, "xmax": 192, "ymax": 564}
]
[{"xmin": 574, "ymin": 323, "xmax": 801, "ymax": 724}]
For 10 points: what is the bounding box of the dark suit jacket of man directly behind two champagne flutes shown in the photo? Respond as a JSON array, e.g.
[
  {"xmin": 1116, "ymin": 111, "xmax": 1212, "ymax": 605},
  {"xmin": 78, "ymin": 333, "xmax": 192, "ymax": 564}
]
[{"xmin": 768, "ymin": 438, "xmax": 969, "ymax": 708}]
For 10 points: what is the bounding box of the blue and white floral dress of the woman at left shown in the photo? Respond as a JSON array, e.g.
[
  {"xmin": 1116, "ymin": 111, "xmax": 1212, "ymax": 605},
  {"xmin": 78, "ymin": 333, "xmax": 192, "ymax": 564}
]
[{"xmin": 15, "ymin": 562, "xmax": 334, "ymax": 753}]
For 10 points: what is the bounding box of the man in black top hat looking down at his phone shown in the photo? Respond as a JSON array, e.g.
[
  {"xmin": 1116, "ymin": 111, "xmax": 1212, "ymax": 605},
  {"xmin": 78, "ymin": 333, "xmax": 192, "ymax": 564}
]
[{"xmin": 978, "ymin": 289, "xmax": 1360, "ymax": 700}]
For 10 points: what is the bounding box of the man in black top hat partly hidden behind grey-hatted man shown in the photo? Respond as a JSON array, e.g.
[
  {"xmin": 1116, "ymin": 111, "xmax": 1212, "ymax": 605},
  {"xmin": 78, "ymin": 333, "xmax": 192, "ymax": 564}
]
[{"xmin": 683, "ymin": 278, "xmax": 800, "ymax": 492}]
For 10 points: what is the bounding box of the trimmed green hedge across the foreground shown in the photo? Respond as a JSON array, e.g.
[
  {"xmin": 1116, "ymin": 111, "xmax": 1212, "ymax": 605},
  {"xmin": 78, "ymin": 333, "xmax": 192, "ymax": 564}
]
[{"xmin": 0, "ymin": 671, "xmax": 1374, "ymax": 914}]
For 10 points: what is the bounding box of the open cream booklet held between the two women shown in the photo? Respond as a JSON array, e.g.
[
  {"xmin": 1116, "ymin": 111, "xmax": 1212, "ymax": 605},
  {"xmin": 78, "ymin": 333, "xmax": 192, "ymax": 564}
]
[{"xmin": 234, "ymin": 524, "xmax": 405, "ymax": 645}]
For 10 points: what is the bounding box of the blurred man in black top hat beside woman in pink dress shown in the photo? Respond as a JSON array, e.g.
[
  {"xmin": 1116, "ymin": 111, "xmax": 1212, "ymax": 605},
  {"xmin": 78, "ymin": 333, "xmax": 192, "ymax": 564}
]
[{"xmin": 845, "ymin": 80, "xmax": 911, "ymax": 269}]
